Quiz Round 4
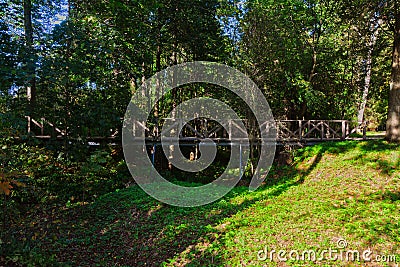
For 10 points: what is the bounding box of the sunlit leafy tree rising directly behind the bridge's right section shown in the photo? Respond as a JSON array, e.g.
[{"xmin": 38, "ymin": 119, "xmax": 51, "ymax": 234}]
[{"xmin": 241, "ymin": 0, "xmax": 348, "ymax": 119}]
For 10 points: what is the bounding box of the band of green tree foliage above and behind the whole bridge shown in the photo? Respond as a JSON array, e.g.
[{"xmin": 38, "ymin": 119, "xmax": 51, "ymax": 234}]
[{"xmin": 0, "ymin": 0, "xmax": 394, "ymax": 134}]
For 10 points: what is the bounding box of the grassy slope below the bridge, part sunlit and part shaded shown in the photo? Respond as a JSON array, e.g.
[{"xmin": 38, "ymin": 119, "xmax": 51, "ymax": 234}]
[{"xmin": 0, "ymin": 141, "xmax": 400, "ymax": 266}]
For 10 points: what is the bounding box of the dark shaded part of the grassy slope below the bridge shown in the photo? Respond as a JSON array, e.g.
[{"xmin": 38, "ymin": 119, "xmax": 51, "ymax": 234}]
[{"xmin": 0, "ymin": 141, "xmax": 399, "ymax": 266}]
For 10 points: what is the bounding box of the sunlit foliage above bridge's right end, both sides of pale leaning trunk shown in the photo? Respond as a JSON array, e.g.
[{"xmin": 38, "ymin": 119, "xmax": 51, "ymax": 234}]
[{"xmin": 239, "ymin": 0, "xmax": 392, "ymax": 125}]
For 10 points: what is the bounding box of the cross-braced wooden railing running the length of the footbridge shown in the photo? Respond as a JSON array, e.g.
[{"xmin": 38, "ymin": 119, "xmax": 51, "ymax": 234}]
[{"xmin": 26, "ymin": 116, "xmax": 374, "ymax": 141}]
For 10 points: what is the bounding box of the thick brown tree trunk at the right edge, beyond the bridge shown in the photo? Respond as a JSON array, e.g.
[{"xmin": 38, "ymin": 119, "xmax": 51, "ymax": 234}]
[{"xmin": 386, "ymin": 10, "xmax": 400, "ymax": 142}]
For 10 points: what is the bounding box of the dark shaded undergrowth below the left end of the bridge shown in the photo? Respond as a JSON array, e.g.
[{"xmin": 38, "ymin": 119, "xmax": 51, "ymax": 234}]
[{"xmin": 0, "ymin": 136, "xmax": 130, "ymax": 210}]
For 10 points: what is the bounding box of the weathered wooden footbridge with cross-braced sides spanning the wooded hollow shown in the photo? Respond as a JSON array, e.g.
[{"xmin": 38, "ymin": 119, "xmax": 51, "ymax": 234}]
[{"xmin": 26, "ymin": 117, "xmax": 368, "ymax": 143}]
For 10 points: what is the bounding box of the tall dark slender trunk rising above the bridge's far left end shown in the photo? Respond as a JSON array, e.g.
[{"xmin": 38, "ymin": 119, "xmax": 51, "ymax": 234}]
[{"xmin": 24, "ymin": 0, "xmax": 36, "ymax": 116}]
